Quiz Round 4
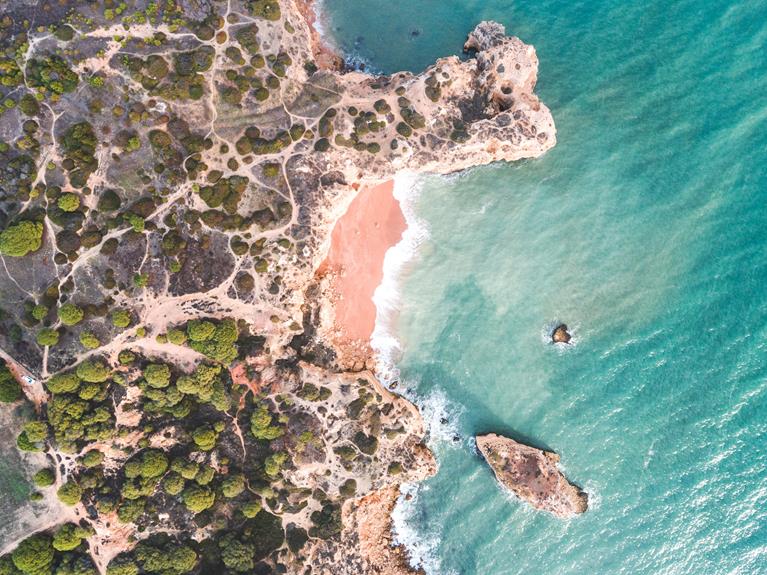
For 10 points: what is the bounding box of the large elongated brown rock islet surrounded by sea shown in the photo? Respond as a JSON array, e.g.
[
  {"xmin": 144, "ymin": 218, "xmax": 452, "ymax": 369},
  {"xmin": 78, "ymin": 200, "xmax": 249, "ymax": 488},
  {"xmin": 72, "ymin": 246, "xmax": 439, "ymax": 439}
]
[{"xmin": 477, "ymin": 433, "xmax": 588, "ymax": 518}]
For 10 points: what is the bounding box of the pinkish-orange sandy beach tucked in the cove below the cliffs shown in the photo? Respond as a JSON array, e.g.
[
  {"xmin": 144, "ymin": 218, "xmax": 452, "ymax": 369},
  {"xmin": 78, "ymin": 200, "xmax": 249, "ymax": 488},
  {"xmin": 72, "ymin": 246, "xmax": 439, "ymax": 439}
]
[{"xmin": 322, "ymin": 181, "xmax": 407, "ymax": 358}]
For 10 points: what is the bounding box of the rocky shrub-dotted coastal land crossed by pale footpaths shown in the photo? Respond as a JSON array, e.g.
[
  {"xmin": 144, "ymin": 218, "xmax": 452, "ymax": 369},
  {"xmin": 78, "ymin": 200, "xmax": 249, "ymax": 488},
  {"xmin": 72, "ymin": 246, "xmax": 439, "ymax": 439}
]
[{"xmin": 0, "ymin": 0, "xmax": 555, "ymax": 575}]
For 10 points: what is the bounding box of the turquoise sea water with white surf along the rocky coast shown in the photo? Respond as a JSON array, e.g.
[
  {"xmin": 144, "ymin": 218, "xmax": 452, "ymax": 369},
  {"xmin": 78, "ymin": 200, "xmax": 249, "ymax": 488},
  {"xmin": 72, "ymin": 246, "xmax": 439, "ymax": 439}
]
[{"xmin": 323, "ymin": 0, "xmax": 767, "ymax": 575}]
